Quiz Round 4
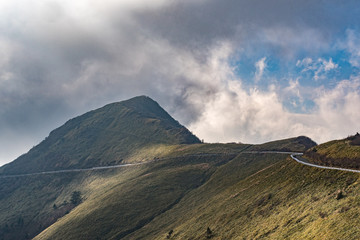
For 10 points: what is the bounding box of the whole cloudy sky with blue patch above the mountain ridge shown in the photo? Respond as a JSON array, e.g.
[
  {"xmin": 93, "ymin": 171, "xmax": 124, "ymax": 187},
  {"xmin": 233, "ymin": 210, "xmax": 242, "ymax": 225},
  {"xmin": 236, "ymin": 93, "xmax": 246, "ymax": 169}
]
[{"xmin": 0, "ymin": 0, "xmax": 360, "ymax": 165}]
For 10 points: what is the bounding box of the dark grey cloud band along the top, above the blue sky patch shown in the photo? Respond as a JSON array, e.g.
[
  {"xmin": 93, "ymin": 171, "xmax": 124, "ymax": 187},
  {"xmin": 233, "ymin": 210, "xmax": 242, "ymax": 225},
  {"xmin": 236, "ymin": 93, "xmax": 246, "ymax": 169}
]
[{"xmin": 135, "ymin": 0, "xmax": 360, "ymax": 49}]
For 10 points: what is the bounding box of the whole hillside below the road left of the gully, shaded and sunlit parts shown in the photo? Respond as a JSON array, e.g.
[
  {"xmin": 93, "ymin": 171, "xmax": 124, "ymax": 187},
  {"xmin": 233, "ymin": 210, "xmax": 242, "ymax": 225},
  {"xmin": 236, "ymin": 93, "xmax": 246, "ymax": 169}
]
[{"xmin": 0, "ymin": 144, "xmax": 248, "ymax": 239}]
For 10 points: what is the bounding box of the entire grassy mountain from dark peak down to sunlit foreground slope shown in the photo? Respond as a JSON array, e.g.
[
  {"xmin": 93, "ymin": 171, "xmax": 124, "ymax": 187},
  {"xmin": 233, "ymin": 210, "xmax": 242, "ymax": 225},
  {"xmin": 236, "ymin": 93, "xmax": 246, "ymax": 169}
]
[{"xmin": 0, "ymin": 97, "xmax": 360, "ymax": 240}]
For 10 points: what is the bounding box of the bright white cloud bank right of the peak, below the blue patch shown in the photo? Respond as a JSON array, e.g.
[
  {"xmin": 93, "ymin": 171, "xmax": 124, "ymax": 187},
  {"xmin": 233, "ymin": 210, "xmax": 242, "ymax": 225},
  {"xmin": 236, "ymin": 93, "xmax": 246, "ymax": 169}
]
[{"xmin": 189, "ymin": 53, "xmax": 360, "ymax": 142}]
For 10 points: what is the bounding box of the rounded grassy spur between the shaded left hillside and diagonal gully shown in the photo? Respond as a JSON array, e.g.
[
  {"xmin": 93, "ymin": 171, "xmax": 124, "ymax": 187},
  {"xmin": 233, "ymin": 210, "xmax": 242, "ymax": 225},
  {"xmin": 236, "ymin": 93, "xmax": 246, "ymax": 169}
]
[{"xmin": 35, "ymin": 166, "xmax": 211, "ymax": 239}]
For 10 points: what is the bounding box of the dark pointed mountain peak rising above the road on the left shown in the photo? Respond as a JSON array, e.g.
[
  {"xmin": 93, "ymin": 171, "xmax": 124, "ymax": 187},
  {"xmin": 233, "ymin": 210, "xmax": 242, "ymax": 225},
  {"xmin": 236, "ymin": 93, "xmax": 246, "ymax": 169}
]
[{"xmin": 0, "ymin": 96, "xmax": 200, "ymax": 174}]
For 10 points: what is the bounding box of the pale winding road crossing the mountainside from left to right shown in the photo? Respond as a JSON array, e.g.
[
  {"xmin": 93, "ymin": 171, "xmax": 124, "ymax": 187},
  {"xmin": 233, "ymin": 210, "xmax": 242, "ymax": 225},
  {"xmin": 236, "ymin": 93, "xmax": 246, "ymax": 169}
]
[{"xmin": 0, "ymin": 151, "xmax": 360, "ymax": 179}]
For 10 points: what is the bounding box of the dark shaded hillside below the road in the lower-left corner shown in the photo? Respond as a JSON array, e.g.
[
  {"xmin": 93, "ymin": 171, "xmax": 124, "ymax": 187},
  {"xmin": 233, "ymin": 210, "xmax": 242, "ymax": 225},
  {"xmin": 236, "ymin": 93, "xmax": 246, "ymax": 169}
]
[{"xmin": 0, "ymin": 173, "xmax": 94, "ymax": 240}]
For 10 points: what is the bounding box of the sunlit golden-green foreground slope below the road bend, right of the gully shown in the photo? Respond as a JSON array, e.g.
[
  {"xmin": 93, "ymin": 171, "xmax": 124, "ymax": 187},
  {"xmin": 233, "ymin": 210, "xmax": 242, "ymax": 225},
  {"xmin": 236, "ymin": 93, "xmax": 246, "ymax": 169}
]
[{"xmin": 120, "ymin": 154, "xmax": 360, "ymax": 239}]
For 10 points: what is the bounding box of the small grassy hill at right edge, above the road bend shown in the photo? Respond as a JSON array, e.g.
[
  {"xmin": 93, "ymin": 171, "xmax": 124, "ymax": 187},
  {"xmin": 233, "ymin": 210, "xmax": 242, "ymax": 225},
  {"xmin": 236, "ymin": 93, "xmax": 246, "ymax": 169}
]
[{"xmin": 304, "ymin": 134, "xmax": 360, "ymax": 169}]
